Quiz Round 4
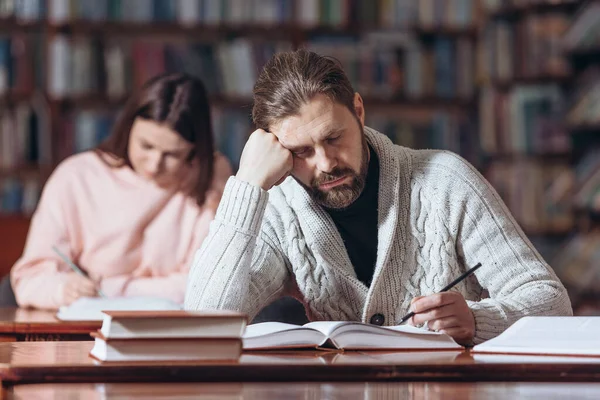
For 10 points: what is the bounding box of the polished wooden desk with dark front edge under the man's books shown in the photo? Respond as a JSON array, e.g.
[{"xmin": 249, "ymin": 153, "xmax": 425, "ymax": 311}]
[{"xmin": 0, "ymin": 342, "xmax": 600, "ymax": 386}]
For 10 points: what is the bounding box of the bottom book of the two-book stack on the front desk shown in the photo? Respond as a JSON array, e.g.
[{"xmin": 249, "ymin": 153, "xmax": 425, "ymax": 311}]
[{"xmin": 90, "ymin": 332, "xmax": 242, "ymax": 362}]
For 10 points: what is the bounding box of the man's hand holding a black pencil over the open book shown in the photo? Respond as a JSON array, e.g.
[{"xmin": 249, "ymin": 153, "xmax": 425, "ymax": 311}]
[{"xmin": 408, "ymin": 291, "xmax": 475, "ymax": 345}]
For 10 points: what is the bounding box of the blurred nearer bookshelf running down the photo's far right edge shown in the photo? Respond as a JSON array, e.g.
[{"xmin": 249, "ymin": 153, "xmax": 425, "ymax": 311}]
[{"xmin": 554, "ymin": 0, "xmax": 600, "ymax": 315}]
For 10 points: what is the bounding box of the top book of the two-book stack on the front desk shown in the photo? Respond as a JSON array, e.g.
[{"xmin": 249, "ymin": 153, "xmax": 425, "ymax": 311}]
[{"xmin": 100, "ymin": 310, "xmax": 247, "ymax": 339}]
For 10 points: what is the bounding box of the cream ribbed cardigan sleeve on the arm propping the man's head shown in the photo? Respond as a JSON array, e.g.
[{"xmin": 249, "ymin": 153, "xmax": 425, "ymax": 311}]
[{"xmin": 185, "ymin": 177, "xmax": 289, "ymax": 320}]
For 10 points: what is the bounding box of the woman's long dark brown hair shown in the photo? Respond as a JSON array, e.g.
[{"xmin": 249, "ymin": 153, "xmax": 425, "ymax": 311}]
[{"xmin": 96, "ymin": 73, "xmax": 214, "ymax": 206}]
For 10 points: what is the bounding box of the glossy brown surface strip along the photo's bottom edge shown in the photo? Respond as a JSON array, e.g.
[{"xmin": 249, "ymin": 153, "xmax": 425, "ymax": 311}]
[{"xmin": 2, "ymin": 382, "xmax": 600, "ymax": 400}]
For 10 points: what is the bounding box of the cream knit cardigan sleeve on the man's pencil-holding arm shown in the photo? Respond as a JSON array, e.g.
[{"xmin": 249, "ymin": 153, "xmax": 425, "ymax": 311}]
[{"xmin": 438, "ymin": 155, "xmax": 573, "ymax": 344}]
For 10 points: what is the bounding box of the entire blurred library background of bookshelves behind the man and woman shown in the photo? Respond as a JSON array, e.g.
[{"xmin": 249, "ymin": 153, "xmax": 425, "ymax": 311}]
[{"xmin": 0, "ymin": 0, "xmax": 600, "ymax": 315}]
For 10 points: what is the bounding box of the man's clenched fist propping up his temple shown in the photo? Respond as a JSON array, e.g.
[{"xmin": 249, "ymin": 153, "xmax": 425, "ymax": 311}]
[{"xmin": 236, "ymin": 129, "xmax": 294, "ymax": 190}]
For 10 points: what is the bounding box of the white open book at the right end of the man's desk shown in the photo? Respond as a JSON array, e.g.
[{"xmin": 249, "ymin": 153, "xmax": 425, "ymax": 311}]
[{"xmin": 473, "ymin": 317, "xmax": 600, "ymax": 356}]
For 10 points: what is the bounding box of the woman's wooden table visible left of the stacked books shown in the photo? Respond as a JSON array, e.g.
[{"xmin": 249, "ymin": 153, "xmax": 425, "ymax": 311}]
[{"xmin": 0, "ymin": 308, "xmax": 102, "ymax": 342}]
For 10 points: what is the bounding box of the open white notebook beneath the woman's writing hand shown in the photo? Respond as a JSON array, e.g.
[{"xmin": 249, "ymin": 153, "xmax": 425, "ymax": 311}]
[{"xmin": 56, "ymin": 297, "xmax": 182, "ymax": 321}]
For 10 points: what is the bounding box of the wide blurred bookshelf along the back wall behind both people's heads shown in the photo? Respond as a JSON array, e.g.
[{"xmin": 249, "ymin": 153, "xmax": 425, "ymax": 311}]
[{"xmin": 0, "ymin": 0, "xmax": 481, "ymax": 276}]
